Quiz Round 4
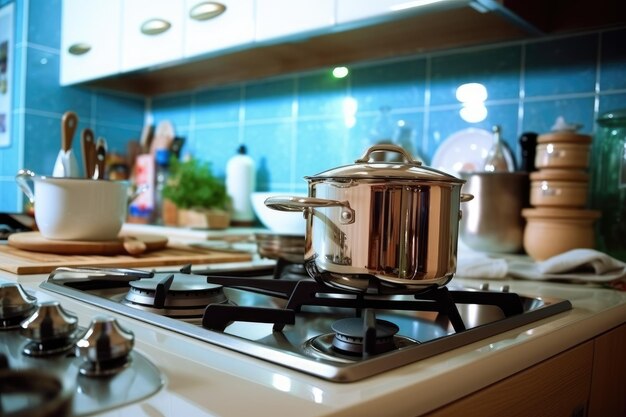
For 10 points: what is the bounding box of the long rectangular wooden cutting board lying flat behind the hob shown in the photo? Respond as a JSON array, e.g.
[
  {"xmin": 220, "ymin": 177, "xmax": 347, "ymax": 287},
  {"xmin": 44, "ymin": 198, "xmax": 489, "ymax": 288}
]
[{"xmin": 0, "ymin": 240, "xmax": 252, "ymax": 275}]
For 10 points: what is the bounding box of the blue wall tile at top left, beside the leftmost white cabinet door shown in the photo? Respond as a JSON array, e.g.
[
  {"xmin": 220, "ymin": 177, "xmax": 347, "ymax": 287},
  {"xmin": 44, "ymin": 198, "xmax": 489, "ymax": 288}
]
[{"xmin": 27, "ymin": 0, "xmax": 61, "ymax": 49}]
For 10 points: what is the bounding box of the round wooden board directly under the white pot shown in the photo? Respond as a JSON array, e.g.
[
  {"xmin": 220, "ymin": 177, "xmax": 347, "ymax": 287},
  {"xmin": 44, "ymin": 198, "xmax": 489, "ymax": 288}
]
[{"xmin": 8, "ymin": 232, "xmax": 167, "ymax": 255}]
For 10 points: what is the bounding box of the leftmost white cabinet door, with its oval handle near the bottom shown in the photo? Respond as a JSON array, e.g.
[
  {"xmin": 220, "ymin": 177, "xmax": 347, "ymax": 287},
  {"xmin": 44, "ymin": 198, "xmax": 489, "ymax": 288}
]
[{"xmin": 60, "ymin": 0, "xmax": 121, "ymax": 85}]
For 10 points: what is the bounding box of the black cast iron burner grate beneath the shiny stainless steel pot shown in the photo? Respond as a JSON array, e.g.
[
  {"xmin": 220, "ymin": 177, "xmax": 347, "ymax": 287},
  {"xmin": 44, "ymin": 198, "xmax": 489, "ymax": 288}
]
[{"xmin": 202, "ymin": 276, "xmax": 524, "ymax": 358}]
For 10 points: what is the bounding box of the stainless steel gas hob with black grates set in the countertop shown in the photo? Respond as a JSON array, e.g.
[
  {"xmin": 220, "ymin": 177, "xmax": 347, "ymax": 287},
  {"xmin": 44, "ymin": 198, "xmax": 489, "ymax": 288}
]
[{"xmin": 41, "ymin": 262, "xmax": 571, "ymax": 382}]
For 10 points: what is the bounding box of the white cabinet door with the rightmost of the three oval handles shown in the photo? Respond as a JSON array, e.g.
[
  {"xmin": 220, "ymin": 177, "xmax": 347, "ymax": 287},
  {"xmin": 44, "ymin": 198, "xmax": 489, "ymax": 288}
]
[{"xmin": 184, "ymin": 0, "xmax": 254, "ymax": 57}]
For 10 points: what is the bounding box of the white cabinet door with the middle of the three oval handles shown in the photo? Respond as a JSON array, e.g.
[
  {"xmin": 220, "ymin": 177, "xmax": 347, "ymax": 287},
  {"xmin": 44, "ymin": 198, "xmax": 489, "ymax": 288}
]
[{"xmin": 122, "ymin": 0, "xmax": 184, "ymax": 71}]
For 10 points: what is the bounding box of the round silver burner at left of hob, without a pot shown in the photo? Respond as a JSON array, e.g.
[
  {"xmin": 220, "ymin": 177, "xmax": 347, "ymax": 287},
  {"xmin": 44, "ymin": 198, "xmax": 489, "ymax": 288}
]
[{"xmin": 122, "ymin": 273, "xmax": 228, "ymax": 318}]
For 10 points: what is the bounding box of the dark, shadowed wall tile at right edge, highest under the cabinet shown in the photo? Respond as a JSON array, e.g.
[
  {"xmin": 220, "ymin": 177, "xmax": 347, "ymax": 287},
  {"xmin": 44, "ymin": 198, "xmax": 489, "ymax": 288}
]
[{"xmin": 600, "ymin": 28, "xmax": 626, "ymax": 92}]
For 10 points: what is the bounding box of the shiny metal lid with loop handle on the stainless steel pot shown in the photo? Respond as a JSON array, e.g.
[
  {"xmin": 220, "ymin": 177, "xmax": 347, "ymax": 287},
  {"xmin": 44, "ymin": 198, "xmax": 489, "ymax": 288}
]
[{"xmin": 305, "ymin": 144, "xmax": 465, "ymax": 184}]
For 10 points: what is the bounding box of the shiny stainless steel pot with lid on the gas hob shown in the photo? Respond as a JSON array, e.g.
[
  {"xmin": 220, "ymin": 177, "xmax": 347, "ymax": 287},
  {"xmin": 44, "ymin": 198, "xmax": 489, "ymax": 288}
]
[{"xmin": 265, "ymin": 145, "xmax": 472, "ymax": 293}]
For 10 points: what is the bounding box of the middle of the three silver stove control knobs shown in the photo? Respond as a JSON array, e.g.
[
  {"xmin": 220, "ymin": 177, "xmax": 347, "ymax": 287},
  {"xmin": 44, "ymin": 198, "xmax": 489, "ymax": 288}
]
[{"xmin": 20, "ymin": 301, "xmax": 78, "ymax": 356}]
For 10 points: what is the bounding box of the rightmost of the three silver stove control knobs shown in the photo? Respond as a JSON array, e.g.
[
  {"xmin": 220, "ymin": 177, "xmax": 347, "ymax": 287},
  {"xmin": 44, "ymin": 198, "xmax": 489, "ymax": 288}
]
[{"xmin": 76, "ymin": 317, "xmax": 135, "ymax": 376}]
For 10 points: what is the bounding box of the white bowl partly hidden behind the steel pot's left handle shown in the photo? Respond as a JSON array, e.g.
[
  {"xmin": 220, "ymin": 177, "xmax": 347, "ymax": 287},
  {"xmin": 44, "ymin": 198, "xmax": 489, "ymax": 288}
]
[{"xmin": 250, "ymin": 191, "xmax": 307, "ymax": 236}]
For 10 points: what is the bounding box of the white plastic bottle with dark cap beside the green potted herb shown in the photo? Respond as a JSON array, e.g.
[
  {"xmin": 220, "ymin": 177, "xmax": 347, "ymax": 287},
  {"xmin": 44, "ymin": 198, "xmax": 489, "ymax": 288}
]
[{"xmin": 226, "ymin": 145, "xmax": 256, "ymax": 225}]
